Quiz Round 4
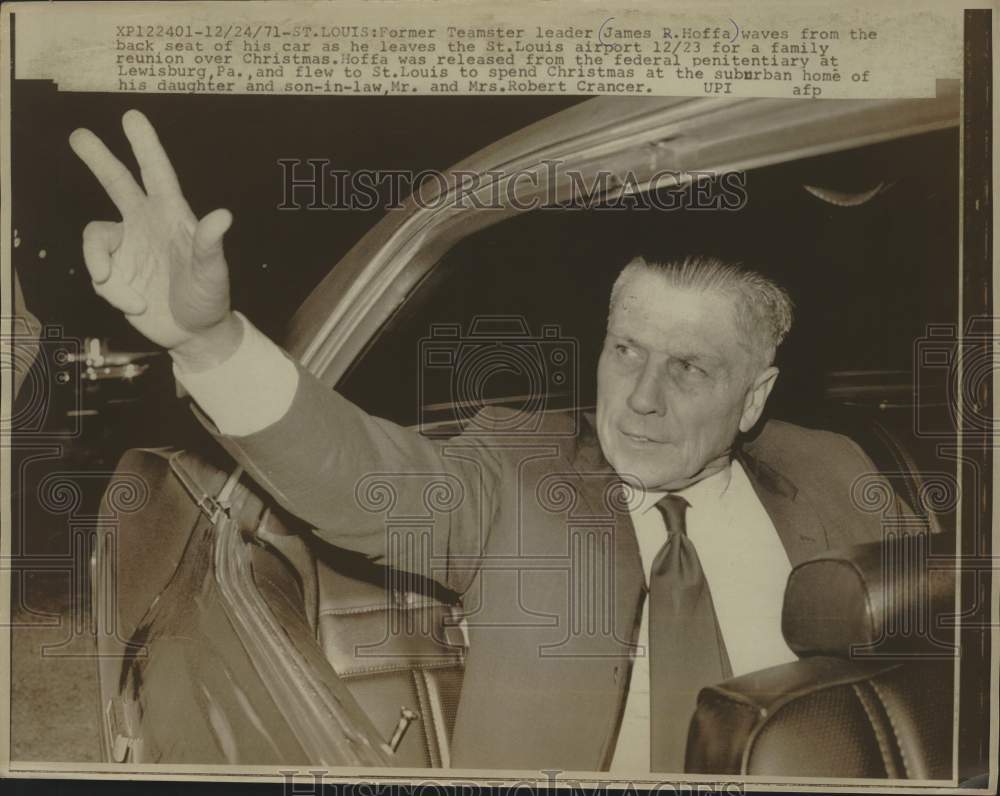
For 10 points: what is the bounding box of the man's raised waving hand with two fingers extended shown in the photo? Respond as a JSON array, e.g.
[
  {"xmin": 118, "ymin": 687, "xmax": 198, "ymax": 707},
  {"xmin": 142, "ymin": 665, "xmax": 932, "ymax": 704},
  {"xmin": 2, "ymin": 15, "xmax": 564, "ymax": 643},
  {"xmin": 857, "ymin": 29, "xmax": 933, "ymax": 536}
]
[{"xmin": 69, "ymin": 110, "xmax": 242, "ymax": 370}]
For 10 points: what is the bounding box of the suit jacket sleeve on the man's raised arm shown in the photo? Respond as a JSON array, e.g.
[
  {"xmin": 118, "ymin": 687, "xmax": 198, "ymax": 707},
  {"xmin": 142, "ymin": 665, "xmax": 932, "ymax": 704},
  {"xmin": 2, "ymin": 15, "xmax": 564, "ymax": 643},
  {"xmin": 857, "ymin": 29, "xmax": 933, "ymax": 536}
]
[{"xmin": 203, "ymin": 358, "xmax": 500, "ymax": 592}]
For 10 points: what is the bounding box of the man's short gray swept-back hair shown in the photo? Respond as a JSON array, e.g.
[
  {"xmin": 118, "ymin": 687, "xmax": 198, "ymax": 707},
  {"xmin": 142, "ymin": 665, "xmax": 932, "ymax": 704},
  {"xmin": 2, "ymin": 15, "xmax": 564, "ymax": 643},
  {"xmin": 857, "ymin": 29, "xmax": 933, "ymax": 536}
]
[{"xmin": 610, "ymin": 255, "xmax": 793, "ymax": 367}]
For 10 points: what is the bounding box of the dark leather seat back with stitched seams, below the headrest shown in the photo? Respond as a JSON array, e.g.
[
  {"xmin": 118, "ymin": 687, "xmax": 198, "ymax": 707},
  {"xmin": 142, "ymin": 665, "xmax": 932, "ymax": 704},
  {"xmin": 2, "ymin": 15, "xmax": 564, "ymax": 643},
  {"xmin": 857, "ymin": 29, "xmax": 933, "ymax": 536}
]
[{"xmin": 685, "ymin": 656, "xmax": 954, "ymax": 779}]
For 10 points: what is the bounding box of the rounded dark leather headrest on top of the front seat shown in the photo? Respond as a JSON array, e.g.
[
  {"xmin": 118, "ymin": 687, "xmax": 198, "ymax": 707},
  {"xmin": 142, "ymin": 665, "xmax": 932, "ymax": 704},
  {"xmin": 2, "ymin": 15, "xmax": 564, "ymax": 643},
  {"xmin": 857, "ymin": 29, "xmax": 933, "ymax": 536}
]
[{"xmin": 781, "ymin": 533, "xmax": 955, "ymax": 658}]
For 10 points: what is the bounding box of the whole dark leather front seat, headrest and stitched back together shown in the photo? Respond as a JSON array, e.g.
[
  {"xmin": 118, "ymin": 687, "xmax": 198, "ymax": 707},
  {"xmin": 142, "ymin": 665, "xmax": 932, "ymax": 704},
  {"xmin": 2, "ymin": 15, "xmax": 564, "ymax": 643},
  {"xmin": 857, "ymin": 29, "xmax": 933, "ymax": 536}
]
[{"xmin": 686, "ymin": 534, "xmax": 956, "ymax": 779}]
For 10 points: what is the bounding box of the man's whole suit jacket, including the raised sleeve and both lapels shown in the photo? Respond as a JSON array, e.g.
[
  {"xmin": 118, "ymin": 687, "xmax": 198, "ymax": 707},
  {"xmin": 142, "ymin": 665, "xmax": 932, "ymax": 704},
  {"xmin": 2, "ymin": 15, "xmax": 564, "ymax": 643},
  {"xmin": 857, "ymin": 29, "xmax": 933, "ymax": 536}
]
[{"xmin": 211, "ymin": 362, "xmax": 900, "ymax": 772}]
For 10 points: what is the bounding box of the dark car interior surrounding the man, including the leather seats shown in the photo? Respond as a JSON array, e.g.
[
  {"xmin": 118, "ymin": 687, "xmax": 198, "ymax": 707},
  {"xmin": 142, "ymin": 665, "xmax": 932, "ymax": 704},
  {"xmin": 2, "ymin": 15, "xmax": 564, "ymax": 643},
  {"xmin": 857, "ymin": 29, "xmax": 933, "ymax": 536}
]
[{"xmin": 227, "ymin": 130, "xmax": 958, "ymax": 779}]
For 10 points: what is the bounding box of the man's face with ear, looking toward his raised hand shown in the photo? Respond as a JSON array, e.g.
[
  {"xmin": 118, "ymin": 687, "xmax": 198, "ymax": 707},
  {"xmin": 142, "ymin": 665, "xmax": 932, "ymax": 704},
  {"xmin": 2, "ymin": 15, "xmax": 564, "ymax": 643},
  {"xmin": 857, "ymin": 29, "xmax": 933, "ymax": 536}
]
[{"xmin": 597, "ymin": 270, "xmax": 777, "ymax": 491}]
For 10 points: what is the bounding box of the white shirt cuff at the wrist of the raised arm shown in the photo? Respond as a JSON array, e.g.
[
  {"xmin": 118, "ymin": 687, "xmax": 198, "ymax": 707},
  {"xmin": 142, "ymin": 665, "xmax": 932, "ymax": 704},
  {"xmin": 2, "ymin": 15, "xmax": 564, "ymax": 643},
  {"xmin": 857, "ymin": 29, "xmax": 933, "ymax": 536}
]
[{"xmin": 174, "ymin": 312, "xmax": 299, "ymax": 437}]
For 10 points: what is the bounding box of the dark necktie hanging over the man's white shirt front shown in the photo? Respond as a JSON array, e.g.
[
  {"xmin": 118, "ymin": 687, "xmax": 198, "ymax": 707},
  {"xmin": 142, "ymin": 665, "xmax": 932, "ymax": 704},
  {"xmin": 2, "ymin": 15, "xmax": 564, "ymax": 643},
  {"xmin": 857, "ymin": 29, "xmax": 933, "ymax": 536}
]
[{"xmin": 649, "ymin": 495, "xmax": 732, "ymax": 773}]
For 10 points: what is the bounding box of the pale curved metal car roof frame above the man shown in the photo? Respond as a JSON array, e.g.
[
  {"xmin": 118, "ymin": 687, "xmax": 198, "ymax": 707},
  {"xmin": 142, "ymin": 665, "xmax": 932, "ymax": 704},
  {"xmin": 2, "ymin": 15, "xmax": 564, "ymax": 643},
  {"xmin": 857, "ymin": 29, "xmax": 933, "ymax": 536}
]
[{"xmin": 285, "ymin": 80, "xmax": 960, "ymax": 386}]
